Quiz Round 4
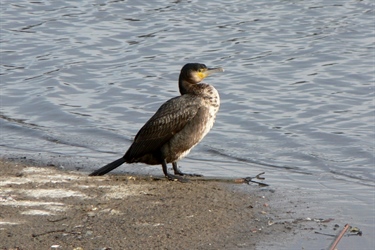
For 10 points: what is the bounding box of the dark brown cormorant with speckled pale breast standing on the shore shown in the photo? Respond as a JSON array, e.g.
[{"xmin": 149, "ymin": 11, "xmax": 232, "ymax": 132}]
[{"xmin": 90, "ymin": 63, "xmax": 224, "ymax": 180}]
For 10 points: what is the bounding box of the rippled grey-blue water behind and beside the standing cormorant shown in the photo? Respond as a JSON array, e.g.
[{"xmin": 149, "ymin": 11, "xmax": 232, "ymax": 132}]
[{"xmin": 0, "ymin": 0, "xmax": 375, "ymax": 249}]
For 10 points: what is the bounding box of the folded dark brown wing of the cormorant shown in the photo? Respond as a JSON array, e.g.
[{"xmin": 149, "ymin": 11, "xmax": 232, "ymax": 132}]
[{"xmin": 125, "ymin": 95, "xmax": 203, "ymax": 160}]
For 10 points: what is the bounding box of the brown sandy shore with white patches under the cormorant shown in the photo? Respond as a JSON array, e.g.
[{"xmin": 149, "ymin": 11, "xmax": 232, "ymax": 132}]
[{"xmin": 0, "ymin": 160, "xmax": 312, "ymax": 250}]
